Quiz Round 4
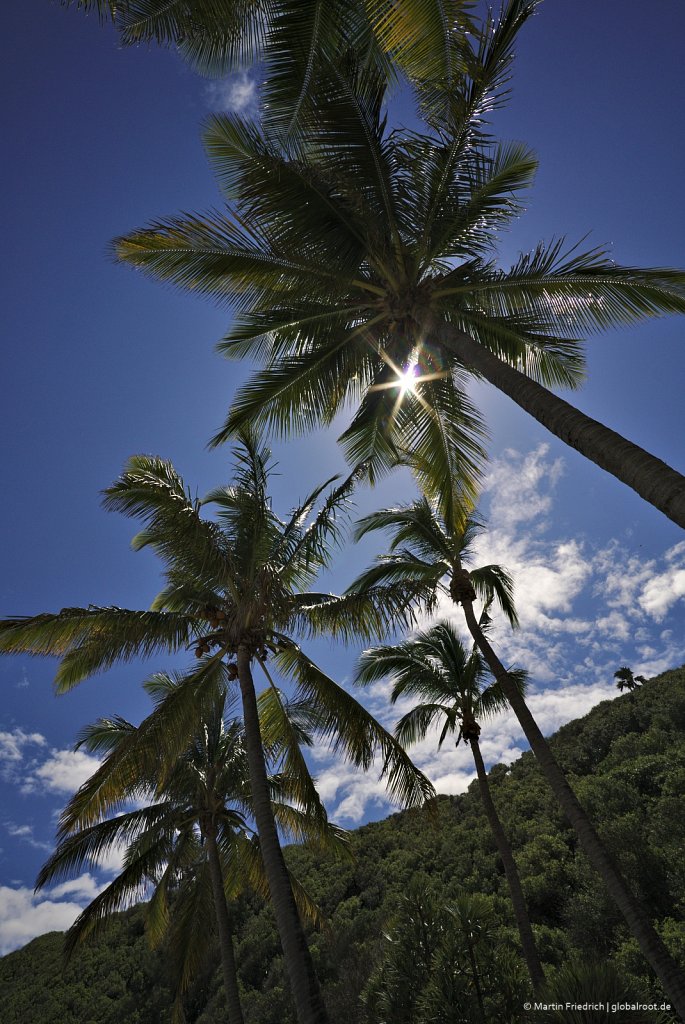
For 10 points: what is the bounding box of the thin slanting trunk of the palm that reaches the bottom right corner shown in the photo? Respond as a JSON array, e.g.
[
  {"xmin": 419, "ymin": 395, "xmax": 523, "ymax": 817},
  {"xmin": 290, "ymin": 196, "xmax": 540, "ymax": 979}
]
[{"xmin": 454, "ymin": 597, "xmax": 685, "ymax": 1021}]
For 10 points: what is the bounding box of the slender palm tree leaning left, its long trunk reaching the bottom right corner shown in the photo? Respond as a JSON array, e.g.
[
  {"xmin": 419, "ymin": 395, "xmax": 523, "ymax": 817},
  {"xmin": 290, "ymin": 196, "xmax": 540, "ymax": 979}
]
[{"xmin": 350, "ymin": 498, "xmax": 685, "ymax": 1017}]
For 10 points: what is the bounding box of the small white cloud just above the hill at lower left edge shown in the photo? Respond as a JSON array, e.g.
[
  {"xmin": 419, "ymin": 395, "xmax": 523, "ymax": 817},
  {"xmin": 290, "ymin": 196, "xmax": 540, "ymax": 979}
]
[{"xmin": 0, "ymin": 873, "xmax": 101, "ymax": 956}]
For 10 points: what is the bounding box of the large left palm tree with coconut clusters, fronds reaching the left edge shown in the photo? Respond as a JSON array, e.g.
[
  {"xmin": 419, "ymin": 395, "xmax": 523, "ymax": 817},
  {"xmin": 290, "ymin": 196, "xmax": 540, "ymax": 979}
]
[{"xmin": 0, "ymin": 433, "xmax": 433, "ymax": 1024}]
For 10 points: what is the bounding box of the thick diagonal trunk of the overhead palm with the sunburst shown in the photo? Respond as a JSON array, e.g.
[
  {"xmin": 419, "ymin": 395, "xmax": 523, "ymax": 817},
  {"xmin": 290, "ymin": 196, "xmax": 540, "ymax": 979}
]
[{"xmin": 434, "ymin": 324, "xmax": 685, "ymax": 527}]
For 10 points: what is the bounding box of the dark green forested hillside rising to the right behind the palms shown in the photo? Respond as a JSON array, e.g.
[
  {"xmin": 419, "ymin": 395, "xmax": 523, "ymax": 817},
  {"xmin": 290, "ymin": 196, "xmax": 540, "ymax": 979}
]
[{"xmin": 0, "ymin": 669, "xmax": 685, "ymax": 1024}]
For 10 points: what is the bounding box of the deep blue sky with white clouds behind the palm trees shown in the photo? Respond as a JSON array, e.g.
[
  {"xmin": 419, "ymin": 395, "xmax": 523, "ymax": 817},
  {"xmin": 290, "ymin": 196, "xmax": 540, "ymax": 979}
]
[{"xmin": 0, "ymin": 0, "xmax": 685, "ymax": 951}]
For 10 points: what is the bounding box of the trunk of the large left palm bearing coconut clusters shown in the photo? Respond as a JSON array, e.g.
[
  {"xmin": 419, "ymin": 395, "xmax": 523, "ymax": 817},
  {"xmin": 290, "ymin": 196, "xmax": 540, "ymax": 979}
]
[{"xmin": 238, "ymin": 644, "xmax": 328, "ymax": 1024}]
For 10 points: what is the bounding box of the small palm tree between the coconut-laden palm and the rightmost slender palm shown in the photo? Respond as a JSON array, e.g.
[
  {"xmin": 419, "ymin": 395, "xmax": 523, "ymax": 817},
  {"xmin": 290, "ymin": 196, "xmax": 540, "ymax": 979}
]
[{"xmin": 357, "ymin": 616, "xmax": 545, "ymax": 990}]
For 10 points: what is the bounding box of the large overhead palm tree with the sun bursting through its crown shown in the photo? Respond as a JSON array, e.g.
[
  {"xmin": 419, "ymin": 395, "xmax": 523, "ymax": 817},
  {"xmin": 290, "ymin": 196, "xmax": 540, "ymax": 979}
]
[{"xmin": 115, "ymin": 9, "xmax": 685, "ymax": 526}]
